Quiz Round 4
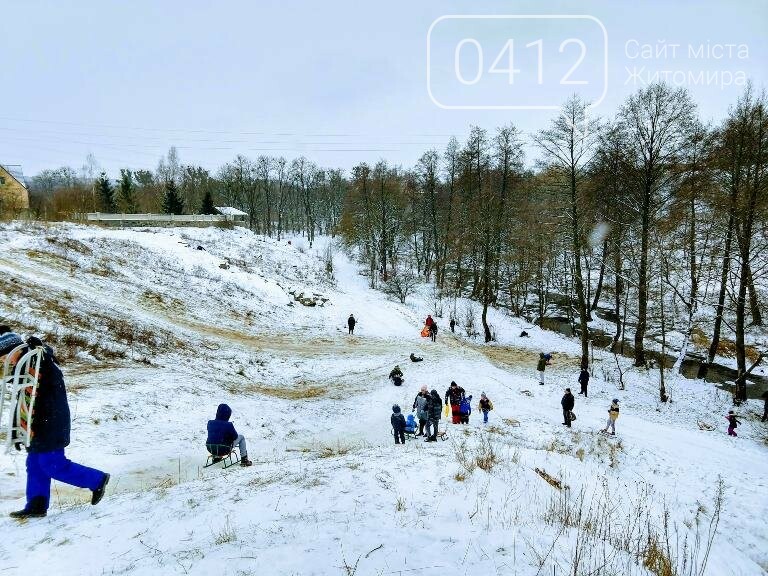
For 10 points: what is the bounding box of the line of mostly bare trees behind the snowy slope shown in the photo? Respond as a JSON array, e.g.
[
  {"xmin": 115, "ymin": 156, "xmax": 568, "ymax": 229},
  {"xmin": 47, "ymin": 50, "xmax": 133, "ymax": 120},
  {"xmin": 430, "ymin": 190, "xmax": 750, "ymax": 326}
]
[{"xmin": 21, "ymin": 83, "xmax": 768, "ymax": 399}]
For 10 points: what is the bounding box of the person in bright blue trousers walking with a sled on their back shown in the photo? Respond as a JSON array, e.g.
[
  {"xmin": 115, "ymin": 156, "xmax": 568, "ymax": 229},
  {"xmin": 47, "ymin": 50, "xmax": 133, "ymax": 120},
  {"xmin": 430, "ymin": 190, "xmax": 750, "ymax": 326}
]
[{"xmin": 0, "ymin": 326, "xmax": 109, "ymax": 519}]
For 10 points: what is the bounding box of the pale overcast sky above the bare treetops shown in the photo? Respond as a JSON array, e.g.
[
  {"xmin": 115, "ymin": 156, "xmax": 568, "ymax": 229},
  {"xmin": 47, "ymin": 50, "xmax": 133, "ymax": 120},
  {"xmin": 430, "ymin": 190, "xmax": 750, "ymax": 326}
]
[{"xmin": 0, "ymin": 0, "xmax": 768, "ymax": 177}]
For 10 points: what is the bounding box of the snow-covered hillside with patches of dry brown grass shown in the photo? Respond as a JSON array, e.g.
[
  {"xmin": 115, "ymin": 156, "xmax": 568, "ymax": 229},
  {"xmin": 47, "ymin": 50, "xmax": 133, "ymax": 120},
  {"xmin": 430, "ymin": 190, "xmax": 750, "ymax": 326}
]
[{"xmin": 0, "ymin": 225, "xmax": 768, "ymax": 576}]
